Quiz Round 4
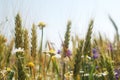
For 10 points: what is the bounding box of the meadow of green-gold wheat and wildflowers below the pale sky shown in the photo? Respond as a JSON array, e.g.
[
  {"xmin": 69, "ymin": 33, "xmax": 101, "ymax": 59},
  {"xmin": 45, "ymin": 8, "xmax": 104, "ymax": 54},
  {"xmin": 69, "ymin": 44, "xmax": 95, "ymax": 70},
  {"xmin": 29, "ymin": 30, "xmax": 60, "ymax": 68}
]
[{"xmin": 0, "ymin": 13, "xmax": 120, "ymax": 80}]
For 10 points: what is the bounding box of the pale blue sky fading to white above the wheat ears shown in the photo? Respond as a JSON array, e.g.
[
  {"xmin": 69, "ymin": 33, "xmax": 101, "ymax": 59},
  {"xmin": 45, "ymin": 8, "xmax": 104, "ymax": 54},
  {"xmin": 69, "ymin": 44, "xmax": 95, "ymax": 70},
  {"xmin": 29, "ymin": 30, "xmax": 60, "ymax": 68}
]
[{"xmin": 0, "ymin": 0, "xmax": 120, "ymax": 47}]
